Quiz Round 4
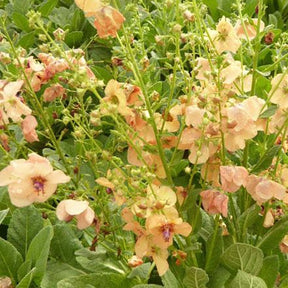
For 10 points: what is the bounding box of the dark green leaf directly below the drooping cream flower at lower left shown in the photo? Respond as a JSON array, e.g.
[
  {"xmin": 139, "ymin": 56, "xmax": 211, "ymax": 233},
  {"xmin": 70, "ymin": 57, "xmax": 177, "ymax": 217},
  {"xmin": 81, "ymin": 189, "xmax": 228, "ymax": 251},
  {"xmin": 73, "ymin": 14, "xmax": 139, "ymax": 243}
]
[{"xmin": 50, "ymin": 224, "xmax": 83, "ymax": 267}]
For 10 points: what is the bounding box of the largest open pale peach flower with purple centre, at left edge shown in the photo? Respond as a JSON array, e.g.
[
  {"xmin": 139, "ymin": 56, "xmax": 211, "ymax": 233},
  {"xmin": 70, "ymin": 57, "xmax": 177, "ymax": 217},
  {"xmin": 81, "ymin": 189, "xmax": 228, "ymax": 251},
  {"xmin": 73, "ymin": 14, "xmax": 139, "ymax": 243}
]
[{"xmin": 0, "ymin": 153, "xmax": 70, "ymax": 207}]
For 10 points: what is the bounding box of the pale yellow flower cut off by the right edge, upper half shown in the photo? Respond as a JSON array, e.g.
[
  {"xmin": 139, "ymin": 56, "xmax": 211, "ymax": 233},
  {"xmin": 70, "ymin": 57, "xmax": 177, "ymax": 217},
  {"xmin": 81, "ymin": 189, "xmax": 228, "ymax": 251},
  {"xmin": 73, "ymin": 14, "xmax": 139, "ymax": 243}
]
[{"xmin": 270, "ymin": 74, "xmax": 288, "ymax": 109}]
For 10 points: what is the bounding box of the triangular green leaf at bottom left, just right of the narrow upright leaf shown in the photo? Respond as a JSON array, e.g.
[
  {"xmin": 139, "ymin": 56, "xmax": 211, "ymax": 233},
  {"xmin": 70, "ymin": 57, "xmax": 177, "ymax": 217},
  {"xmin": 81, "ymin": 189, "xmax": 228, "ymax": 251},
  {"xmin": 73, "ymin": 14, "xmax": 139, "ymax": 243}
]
[{"xmin": 41, "ymin": 261, "xmax": 86, "ymax": 288}]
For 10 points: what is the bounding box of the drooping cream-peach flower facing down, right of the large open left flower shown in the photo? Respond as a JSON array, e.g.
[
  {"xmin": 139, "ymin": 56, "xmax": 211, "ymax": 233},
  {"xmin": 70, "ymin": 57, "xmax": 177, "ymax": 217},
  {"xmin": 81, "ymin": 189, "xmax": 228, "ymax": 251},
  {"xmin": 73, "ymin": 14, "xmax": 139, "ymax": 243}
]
[{"xmin": 56, "ymin": 199, "xmax": 95, "ymax": 229}]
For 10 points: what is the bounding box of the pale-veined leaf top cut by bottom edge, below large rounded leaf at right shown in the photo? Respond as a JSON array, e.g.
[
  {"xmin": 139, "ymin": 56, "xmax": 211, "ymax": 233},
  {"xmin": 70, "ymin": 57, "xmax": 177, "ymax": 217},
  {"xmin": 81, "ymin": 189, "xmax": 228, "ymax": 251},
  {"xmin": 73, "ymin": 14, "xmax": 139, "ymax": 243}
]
[{"xmin": 225, "ymin": 270, "xmax": 267, "ymax": 288}]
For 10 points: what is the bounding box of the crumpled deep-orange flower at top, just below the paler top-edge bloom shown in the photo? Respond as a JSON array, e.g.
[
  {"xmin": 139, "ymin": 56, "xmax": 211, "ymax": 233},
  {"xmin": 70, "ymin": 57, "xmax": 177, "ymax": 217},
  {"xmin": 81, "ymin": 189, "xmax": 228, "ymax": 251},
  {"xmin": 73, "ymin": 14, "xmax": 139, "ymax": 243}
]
[{"xmin": 93, "ymin": 6, "xmax": 125, "ymax": 38}]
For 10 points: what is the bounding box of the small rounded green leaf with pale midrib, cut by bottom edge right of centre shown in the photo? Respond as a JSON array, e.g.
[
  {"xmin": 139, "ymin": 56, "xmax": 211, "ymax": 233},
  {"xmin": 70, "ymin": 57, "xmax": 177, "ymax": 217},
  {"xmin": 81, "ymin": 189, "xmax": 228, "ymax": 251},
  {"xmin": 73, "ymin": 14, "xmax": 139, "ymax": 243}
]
[{"xmin": 183, "ymin": 267, "xmax": 209, "ymax": 288}]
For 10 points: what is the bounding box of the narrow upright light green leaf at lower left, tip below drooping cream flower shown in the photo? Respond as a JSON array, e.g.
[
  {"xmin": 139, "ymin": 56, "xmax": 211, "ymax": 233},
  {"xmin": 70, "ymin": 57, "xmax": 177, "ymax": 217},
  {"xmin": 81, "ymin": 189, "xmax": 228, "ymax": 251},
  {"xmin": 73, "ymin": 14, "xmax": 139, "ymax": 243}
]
[{"xmin": 26, "ymin": 226, "xmax": 53, "ymax": 285}]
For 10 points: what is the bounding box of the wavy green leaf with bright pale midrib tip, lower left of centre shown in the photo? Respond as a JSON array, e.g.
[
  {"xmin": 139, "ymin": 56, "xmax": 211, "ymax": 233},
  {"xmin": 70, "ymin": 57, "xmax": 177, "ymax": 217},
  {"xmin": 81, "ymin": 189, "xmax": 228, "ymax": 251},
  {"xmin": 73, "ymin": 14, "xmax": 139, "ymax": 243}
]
[{"xmin": 75, "ymin": 246, "xmax": 125, "ymax": 274}]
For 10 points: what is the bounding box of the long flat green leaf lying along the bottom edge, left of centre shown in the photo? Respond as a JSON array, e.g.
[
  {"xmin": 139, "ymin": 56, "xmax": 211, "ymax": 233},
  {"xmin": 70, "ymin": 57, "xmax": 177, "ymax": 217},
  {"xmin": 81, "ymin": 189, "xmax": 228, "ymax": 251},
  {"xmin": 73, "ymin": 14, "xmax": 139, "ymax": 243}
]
[{"xmin": 57, "ymin": 273, "xmax": 128, "ymax": 288}]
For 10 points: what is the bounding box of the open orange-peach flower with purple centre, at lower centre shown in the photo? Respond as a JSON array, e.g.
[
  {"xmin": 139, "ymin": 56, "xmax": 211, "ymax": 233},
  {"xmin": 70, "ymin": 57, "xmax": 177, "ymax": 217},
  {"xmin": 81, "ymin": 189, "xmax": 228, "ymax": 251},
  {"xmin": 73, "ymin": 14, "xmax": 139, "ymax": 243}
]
[{"xmin": 145, "ymin": 207, "xmax": 192, "ymax": 248}]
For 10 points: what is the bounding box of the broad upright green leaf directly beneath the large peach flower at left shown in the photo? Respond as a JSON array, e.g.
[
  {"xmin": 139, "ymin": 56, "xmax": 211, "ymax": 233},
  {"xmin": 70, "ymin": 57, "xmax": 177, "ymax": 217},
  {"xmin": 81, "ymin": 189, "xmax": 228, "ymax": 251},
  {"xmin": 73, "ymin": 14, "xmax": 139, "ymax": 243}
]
[{"xmin": 7, "ymin": 205, "xmax": 43, "ymax": 258}]
